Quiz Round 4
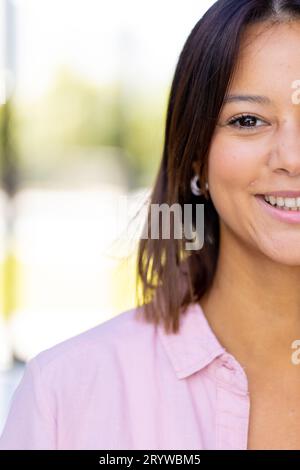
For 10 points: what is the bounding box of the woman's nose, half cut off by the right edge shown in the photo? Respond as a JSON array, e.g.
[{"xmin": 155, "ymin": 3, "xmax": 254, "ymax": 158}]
[{"xmin": 270, "ymin": 116, "xmax": 300, "ymax": 176}]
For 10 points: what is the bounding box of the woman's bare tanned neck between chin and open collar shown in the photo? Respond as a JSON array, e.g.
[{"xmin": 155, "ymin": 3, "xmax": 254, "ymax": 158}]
[{"xmin": 200, "ymin": 225, "xmax": 300, "ymax": 367}]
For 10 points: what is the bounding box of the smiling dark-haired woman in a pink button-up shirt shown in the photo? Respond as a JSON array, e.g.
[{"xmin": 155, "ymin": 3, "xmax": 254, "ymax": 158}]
[{"xmin": 0, "ymin": 0, "xmax": 300, "ymax": 449}]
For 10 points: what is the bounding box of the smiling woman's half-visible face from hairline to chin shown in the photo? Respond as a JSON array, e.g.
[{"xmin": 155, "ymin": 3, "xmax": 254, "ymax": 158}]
[{"xmin": 208, "ymin": 21, "xmax": 300, "ymax": 265}]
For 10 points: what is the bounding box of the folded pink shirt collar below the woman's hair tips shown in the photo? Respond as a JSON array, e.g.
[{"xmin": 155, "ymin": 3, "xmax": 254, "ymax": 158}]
[{"xmin": 158, "ymin": 303, "xmax": 225, "ymax": 379}]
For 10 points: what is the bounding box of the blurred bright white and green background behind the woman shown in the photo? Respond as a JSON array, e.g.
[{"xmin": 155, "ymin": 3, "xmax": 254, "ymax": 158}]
[{"xmin": 0, "ymin": 0, "xmax": 214, "ymax": 432}]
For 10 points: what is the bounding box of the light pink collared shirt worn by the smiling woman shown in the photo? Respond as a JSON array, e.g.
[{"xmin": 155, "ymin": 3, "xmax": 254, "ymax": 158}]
[{"xmin": 0, "ymin": 304, "xmax": 249, "ymax": 450}]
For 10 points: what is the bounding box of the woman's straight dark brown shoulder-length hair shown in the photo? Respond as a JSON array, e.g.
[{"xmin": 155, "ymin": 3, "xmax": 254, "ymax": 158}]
[{"xmin": 137, "ymin": 0, "xmax": 300, "ymax": 333}]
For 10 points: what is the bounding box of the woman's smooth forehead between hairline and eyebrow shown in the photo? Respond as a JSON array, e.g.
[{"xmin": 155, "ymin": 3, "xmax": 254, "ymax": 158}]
[{"xmin": 227, "ymin": 21, "xmax": 300, "ymax": 96}]
